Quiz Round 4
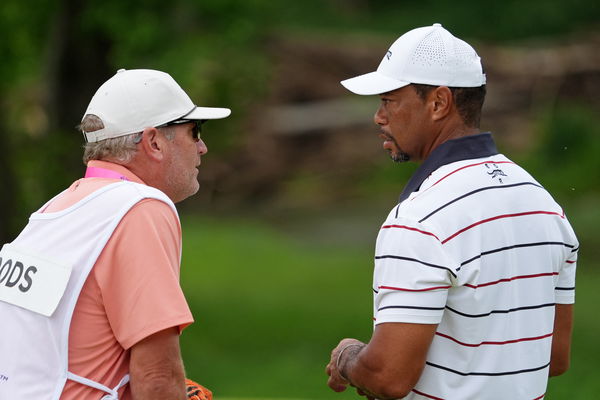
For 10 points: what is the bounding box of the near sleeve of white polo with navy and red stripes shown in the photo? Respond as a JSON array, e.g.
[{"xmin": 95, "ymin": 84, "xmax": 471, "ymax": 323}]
[{"xmin": 373, "ymin": 219, "xmax": 456, "ymax": 325}]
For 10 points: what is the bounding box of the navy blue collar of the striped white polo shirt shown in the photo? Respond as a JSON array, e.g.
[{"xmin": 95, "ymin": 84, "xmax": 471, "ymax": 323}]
[{"xmin": 400, "ymin": 132, "xmax": 498, "ymax": 202}]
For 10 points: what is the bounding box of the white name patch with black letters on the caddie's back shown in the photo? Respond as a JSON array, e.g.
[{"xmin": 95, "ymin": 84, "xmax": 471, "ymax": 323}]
[{"xmin": 0, "ymin": 244, "xmax": 72, "ymax": 317}]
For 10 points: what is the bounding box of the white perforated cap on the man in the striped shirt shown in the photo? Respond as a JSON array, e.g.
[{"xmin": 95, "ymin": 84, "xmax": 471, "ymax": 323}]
[{"xmin": 341, "ymin": 24, "xmax": 485, "ymax": 95}]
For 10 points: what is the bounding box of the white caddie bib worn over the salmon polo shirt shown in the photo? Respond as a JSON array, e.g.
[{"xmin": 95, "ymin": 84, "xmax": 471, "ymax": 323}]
[{"xmin": 0, "ymin": 182, "xmax": 177, "ymax": 400}]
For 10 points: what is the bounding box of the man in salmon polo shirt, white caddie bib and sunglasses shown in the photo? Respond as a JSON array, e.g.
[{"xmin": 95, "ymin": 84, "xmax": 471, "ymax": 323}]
[{"xmin": 0, "ymin": 70, "xmax": 231, "ymax": 400}]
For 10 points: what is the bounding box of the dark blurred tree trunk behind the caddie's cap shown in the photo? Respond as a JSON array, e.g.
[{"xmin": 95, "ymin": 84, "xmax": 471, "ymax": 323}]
[{"xmin": 41, "ymin": 0, "xmax": 113, "ymax": 201}]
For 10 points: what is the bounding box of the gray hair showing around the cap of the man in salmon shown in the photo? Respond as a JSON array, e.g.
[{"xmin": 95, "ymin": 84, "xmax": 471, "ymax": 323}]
[{"xmin": 78, "ymin": 114, "xmax": 175, "ymax": 165}]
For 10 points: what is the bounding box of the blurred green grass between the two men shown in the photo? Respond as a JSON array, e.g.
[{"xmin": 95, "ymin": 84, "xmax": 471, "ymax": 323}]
[{"xmin": 181, "ymin": 218, "xmax": 372, "ymax": 399}]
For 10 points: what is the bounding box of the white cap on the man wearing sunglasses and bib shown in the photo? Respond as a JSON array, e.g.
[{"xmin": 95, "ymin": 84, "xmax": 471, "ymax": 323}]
[{"xmin": 83, "ymin": 69, "xmax": 231, "ymax": 142}]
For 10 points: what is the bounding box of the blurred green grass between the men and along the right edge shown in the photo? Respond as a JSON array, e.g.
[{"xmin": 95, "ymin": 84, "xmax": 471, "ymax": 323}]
[{"xmin": 181, "ymin": 199, "xmax": 600, "ymax": 400}]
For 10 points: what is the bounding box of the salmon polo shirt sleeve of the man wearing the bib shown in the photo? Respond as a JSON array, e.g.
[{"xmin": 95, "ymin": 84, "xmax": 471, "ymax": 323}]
[{"xmin": 96, "ymin": 199, "xmax": 193, "ymax": 349}]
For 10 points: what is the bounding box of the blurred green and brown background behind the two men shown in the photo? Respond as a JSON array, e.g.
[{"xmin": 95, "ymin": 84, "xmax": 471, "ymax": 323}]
[{"xmin": 0, "ymin": 0, "xmax": 600, "ymax": 400}]
